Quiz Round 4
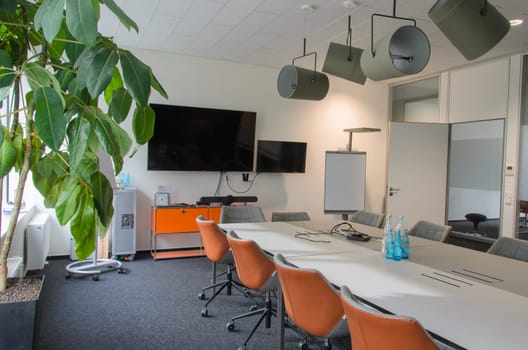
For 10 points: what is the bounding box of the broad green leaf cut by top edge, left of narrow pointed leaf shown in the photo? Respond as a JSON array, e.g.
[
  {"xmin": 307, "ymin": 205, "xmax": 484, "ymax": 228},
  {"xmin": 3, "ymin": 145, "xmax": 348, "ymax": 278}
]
[{"xmin": 66, "ymin": 0, "xmax": 97, "ymax": 46}]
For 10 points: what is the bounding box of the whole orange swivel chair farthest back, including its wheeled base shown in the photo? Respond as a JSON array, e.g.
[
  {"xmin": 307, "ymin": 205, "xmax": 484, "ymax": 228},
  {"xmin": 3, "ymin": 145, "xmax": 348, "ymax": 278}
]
[{"xmin": 196, "ymin": 216, "xmax": 249, "ymax": 317}]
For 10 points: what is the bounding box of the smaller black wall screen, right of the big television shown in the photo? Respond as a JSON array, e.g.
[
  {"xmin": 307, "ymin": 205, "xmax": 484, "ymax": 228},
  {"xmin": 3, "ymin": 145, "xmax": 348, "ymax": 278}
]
[{"xmin": 257, "ymin": 140, "xmax": 306, "ymax": 173}]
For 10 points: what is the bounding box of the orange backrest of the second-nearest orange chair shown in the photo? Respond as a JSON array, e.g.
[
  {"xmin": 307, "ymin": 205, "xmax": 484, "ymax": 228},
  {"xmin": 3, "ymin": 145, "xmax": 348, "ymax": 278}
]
[{"xmin": 274, "ymin": 254, "xmax": 344, "ymax": 338}]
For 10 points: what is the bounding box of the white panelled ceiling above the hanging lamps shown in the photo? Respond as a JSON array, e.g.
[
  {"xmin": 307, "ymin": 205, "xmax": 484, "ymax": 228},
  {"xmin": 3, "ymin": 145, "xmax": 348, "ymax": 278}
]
[{"xmin": 99, "ymin": 0, "xmax": 528, "ymax": 83}]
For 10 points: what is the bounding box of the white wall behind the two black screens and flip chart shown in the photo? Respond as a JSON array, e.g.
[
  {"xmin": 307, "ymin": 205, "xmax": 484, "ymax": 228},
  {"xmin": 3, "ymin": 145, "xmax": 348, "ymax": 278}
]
[{"xmin": 119, "ymin": 50, "xmax": 389, "ymax": 250}]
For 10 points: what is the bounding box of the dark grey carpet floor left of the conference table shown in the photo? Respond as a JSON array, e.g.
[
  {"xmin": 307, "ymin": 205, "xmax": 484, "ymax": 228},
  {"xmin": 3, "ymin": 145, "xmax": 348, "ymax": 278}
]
[{"xmin": 39, "ymin": 254, "xmax": 349, "ymax": 350}]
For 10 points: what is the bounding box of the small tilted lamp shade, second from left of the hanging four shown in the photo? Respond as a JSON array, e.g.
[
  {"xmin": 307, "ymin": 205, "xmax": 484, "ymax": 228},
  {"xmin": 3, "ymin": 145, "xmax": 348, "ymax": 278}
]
[{"xmin": 323, "ymin": 43, "xmax": 367, "ymax": 85}]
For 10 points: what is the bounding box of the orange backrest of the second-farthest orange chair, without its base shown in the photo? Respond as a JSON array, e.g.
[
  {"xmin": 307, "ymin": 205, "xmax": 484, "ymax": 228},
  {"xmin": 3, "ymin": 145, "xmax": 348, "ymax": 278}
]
[{"xmin": 227, "ymin": 232, "xmax": 275, "ymax": 290}]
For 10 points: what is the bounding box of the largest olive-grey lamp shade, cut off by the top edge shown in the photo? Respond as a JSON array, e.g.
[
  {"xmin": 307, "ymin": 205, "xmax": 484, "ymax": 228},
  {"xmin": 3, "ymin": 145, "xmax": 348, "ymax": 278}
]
[{"xmin": 429, "ymin": 0, "xmax": 510, "ymax": 60}]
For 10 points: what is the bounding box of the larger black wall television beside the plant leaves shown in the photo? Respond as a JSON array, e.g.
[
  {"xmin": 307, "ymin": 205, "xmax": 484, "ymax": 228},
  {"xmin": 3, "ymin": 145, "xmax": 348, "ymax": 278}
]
[{"xmin": 147, "ymin": 104, "xmax": 256, "ymax": 171}]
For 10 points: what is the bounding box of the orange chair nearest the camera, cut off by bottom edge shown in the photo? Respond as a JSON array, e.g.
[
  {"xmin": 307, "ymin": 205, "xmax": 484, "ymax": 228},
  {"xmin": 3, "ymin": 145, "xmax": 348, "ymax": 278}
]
[{"xmin": 341, "ymin": 286, "xmax": 439, "ymax": 350}]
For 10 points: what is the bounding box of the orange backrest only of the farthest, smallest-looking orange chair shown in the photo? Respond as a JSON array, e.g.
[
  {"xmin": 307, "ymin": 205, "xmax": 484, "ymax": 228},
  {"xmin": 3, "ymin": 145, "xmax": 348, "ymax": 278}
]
[{"xmin": 196, "ymin": 216, "xmax": 229, "ymax": 262}]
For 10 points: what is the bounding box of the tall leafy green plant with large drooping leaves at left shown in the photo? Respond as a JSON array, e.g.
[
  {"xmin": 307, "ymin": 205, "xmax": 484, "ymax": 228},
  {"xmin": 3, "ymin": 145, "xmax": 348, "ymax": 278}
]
[{"xmin": 0, "ymin": 0, "xmax": 166, "ymax": 346}]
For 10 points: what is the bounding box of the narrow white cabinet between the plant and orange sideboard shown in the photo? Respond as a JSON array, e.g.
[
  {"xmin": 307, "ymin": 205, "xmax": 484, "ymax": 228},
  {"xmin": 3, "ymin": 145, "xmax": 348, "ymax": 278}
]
[{"xmin": 112, "ymin": 188, "xmax": 136, "ymax": 259}]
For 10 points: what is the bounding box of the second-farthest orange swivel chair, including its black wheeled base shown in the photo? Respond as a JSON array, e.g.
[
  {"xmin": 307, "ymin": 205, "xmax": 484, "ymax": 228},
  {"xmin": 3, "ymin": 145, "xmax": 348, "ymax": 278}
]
[{"xmin": 227, "ymin": 231, "xmax": 278, "ymax": 349}]
